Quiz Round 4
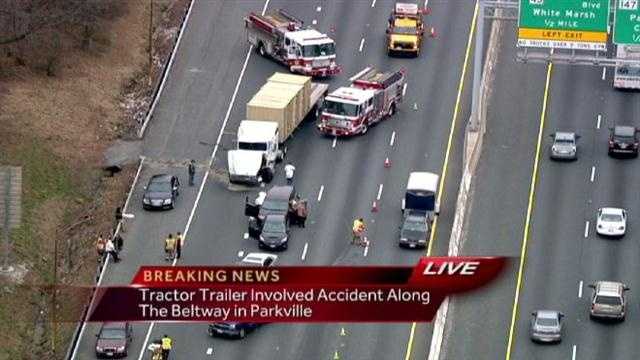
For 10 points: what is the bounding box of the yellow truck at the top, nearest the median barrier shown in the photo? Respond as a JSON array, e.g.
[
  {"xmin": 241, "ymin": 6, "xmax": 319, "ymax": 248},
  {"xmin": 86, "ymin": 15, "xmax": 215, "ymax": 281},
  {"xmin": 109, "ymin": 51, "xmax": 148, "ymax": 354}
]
[{"xmin": 387, "ymin": 3, "xmax": 424, "ymax": 56}]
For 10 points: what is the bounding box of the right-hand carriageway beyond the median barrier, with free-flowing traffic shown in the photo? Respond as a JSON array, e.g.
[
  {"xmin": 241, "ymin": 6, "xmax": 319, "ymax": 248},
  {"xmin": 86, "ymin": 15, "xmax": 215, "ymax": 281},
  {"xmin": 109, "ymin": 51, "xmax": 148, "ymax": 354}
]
[{"xmin": 443, "ymin": 18, "xmax": 640, "ymax": 360}]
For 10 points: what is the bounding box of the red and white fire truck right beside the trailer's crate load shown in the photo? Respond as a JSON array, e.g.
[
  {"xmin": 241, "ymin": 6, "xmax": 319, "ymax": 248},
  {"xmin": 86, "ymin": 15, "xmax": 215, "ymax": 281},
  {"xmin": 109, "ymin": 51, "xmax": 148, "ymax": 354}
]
[{"xmin": 317, "ymin": 67, "xmax": 407, "ymax": 136}]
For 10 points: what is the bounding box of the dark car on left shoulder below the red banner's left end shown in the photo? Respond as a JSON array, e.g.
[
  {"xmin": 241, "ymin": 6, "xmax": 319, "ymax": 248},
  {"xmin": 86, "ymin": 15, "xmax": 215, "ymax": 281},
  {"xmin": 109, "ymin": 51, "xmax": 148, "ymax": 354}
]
[{"xmin": 96, "ymin": 322, "xmax": 133, "ymax": 359}]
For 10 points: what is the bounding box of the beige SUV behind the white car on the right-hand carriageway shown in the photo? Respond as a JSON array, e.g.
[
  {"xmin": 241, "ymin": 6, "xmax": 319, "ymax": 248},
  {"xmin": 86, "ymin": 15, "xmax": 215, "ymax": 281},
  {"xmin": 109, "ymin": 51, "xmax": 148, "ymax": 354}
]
[{"xmin": 589, "ymin": 281, "xmax": 629, "ymax": 321}]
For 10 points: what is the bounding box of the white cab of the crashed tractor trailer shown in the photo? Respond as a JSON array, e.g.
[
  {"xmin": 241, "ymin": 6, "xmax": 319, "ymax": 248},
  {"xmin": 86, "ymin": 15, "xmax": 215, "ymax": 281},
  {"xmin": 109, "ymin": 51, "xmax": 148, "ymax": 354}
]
[{"xmin": 227, "ymin": 120, "xmax": 283, "ymax": 184}]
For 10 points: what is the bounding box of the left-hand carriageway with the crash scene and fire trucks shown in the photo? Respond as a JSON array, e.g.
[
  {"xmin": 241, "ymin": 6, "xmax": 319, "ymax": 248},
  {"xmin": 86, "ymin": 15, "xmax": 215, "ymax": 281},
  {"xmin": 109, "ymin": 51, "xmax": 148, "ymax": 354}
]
[{"xmin": 70, "ymin": 0, "xmax": 474, "ymax": 359}]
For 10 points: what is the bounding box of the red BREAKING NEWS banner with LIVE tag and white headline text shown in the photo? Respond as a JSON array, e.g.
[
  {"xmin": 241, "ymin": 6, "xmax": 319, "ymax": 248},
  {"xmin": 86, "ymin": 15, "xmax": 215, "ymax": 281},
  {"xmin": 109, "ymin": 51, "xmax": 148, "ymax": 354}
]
[{"xmin": 89, "ymin": 257, "xmax": 507, "ymax": 322}]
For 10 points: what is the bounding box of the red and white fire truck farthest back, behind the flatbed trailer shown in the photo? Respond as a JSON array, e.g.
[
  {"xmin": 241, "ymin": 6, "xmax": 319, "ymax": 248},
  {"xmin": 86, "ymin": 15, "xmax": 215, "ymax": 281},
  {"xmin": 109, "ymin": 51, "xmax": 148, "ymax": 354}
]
[{"xmin": 244, "ymin": 9, "xmax": 341, "ymax": 77}]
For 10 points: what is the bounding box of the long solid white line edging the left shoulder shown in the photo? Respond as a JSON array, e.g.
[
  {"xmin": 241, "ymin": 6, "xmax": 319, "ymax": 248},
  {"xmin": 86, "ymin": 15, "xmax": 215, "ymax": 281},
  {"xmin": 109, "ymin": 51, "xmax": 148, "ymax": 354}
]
[{"xmin": 138, "ymin": 0, "xmax": 271, "ymax": 360}]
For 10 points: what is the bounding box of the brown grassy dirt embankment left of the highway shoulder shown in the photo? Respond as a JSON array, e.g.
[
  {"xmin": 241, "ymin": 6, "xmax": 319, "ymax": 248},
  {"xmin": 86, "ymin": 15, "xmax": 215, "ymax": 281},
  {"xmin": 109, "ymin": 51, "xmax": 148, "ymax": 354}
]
[{"xmin": 0, "ymin": 0, "xmax": 188, "ymax": 360}]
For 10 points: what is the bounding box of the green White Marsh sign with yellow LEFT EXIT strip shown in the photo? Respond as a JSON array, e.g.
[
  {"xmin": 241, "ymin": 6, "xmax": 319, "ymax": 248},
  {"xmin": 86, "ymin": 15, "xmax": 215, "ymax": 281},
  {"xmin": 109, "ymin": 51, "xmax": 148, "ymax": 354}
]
[{"xmin": 518, "ymin": 0, "xmax": 609, "ymax": 51}]
